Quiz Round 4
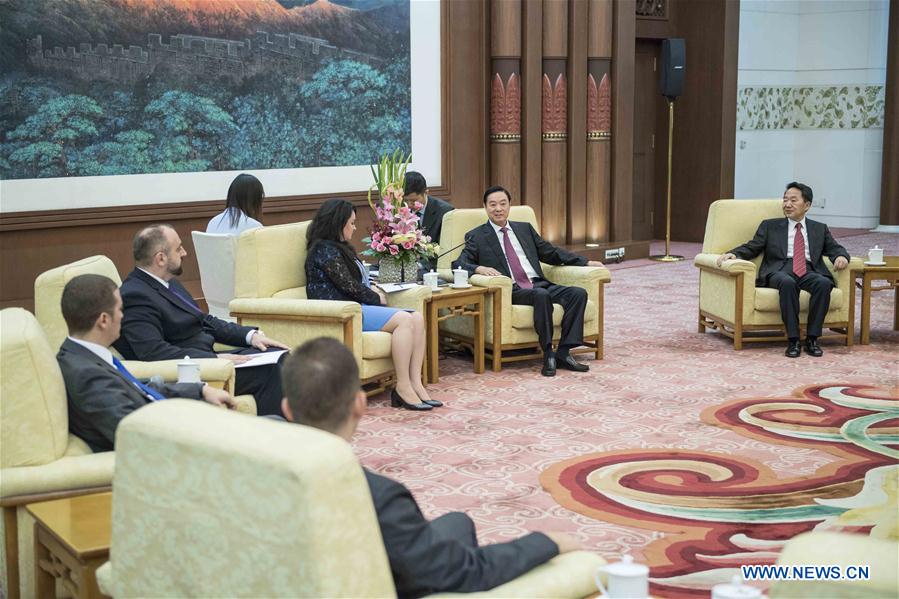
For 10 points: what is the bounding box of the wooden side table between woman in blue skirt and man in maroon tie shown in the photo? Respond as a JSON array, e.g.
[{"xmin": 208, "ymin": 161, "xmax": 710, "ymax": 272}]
[{"xmin": 425, "ymin": 285, "xmax": 488, "ymax": 383}]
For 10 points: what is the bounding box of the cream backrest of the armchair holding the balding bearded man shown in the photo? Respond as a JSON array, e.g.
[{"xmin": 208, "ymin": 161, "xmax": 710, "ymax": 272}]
[{"xmin": 34, "ymin": 256, "xmax": 122, "ymax": 348}]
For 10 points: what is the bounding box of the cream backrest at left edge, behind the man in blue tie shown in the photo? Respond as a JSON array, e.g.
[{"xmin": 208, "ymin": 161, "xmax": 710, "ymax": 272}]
[{"xmin": 0, "ymin": 308, "xmax": 69, "ymax": 468}]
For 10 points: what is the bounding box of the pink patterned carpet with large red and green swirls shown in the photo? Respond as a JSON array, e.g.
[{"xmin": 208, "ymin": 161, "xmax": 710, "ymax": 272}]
[{"xmin": 355, "ymin": 232, "xmax": 899, "ymax": 597}]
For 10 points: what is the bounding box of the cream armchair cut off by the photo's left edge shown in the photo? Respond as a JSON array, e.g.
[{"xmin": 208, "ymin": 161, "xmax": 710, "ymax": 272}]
[{"xmin": 0, "ymin": 308, "xmax": 115, "ymax": 598}]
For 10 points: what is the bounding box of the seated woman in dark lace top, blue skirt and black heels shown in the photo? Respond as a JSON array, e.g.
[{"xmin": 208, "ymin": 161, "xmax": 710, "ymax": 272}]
[{"xmin": 306, "ymin": 199, "xmax": 443, "ymax": 410}]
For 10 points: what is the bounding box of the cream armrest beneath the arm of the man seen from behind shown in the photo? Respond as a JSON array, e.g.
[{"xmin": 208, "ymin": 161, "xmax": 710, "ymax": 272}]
[{"xmin": 430, "ymin": 551, "xmax": 606, "ymax": 599}]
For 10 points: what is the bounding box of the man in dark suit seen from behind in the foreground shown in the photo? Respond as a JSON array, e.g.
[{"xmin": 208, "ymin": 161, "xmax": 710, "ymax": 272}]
[{"xmin": 283, "ymin": 337, "xmax": 579, "ymax": 597}]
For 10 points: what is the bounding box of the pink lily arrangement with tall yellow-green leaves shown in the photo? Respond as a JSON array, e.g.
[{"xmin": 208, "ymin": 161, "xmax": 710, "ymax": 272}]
[{"xmin": 362, "ymin": 150, "xmax": 440, "ymax": 263}]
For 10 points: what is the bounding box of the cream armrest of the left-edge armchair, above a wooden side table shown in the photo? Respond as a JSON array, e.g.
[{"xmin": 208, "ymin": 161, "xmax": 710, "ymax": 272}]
[{"xmin": 0, "ymin": 451, "xmax": 115, "ymax": 504}]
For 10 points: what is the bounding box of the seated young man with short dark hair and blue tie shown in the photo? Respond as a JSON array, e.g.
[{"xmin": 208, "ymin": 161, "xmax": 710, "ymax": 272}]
[{"xmin": 56, "ymin": 275, "xmax": 234, "ymax": 451}]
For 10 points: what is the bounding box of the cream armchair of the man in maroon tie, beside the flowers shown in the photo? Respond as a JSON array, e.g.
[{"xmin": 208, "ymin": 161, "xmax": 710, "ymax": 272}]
[{"xmin": 437, "ymin": 206, "xmax": 612, "ymax": 371}]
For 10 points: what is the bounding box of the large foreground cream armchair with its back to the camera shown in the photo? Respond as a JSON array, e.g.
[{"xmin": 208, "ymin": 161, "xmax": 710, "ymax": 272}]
[{"xmin": 97, "ymin": 401, "xmax": 603, "ymax": 597}]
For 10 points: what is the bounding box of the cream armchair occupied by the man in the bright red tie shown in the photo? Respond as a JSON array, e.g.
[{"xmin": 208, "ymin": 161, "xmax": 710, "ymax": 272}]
[{"xmin": 693, "ymin": 200, "xmax": 862, "ymax": 349}]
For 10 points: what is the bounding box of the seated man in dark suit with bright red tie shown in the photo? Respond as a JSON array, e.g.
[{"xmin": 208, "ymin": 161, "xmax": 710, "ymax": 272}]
[{"xmin": 718, "ymin": 181, "xmax": 851, "ymax": 358}]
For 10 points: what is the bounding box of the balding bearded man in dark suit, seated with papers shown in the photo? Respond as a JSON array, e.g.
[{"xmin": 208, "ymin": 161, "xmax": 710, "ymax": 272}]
[{"xmin": 115, "ymin": 225, "xmax": 287, "ymax": 416}]
